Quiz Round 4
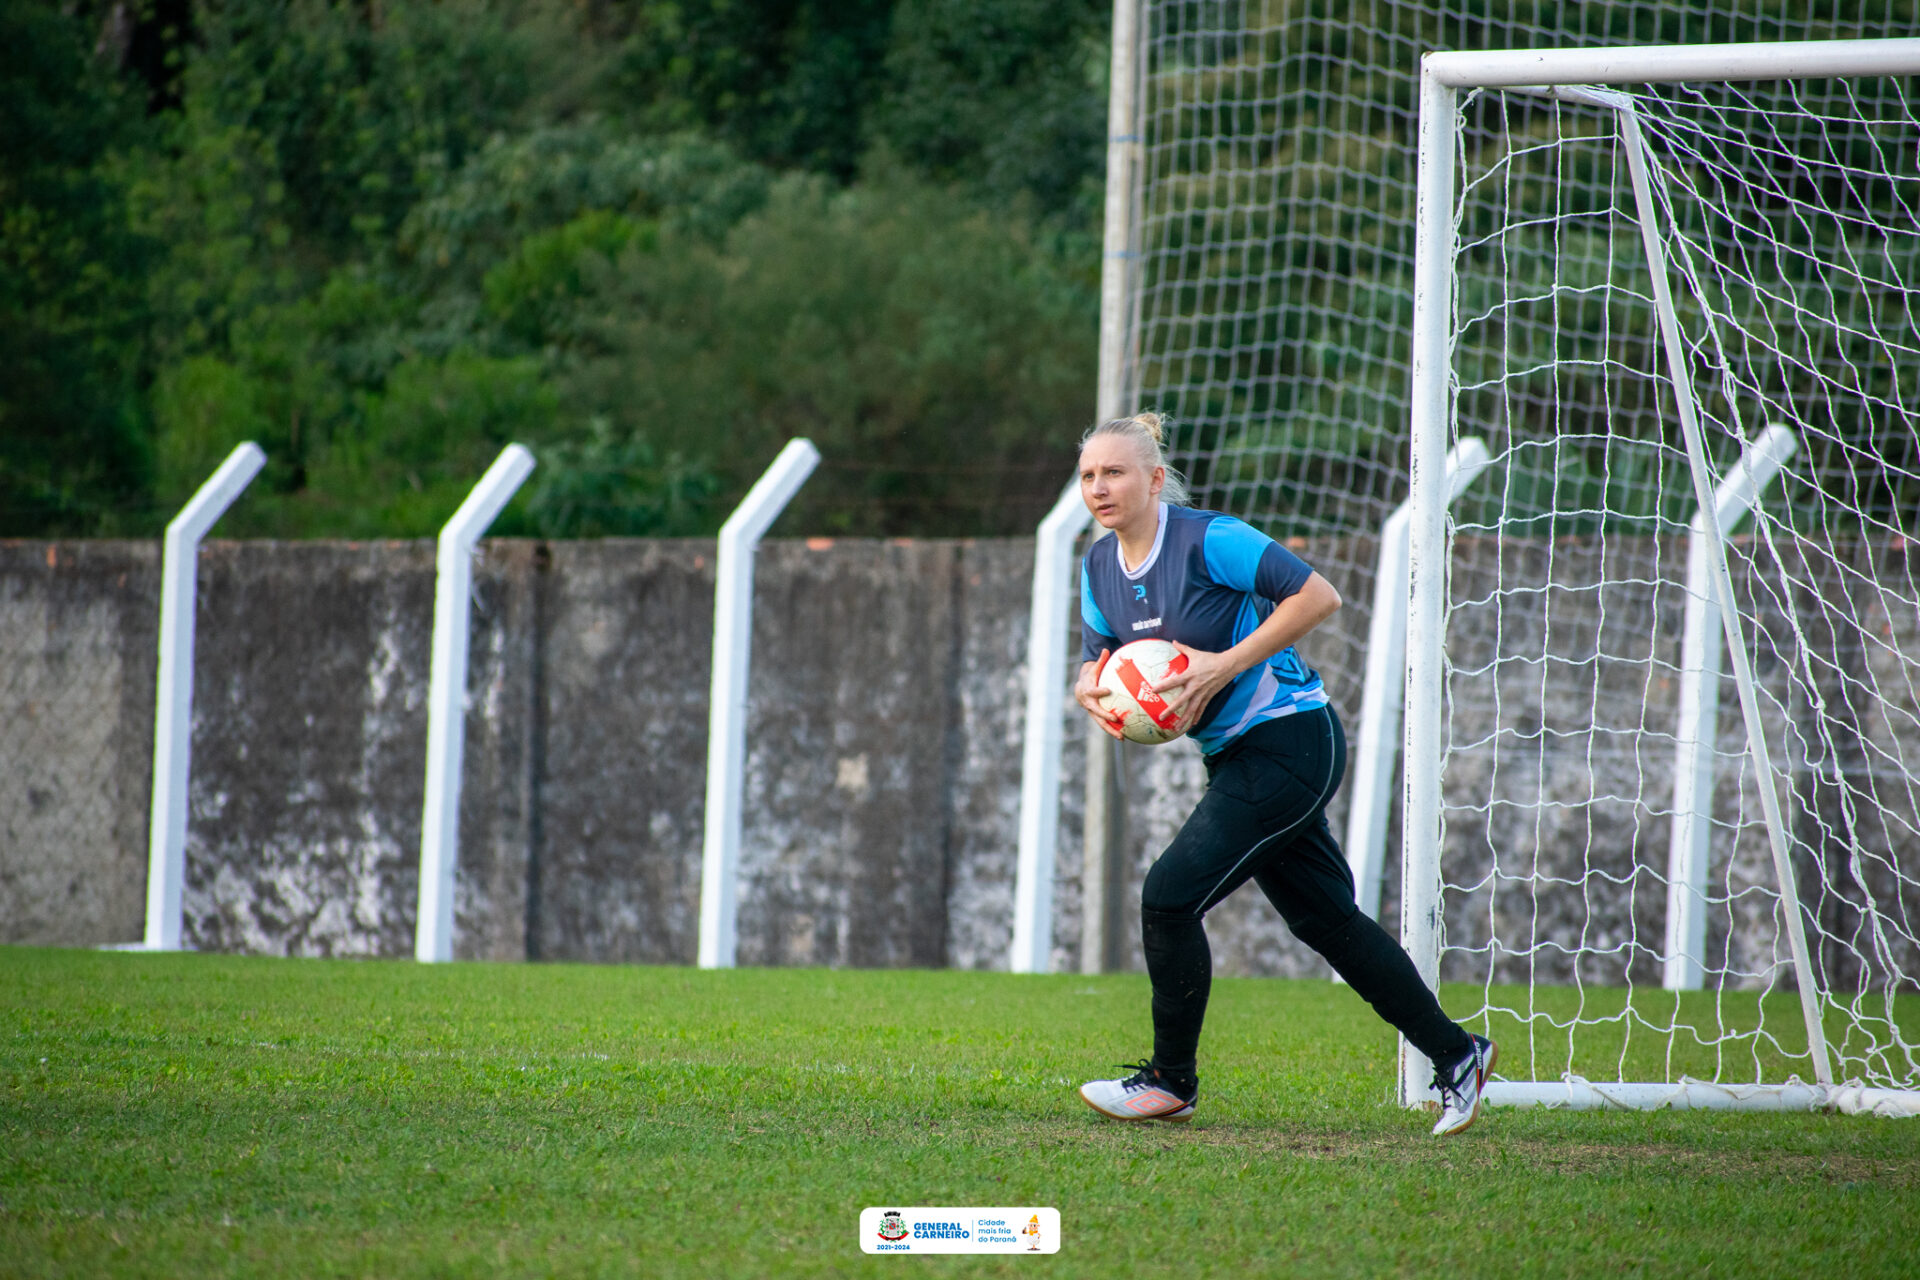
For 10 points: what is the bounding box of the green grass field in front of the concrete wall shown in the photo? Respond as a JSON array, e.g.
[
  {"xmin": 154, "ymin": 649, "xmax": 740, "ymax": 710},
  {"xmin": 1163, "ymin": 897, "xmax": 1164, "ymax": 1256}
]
[{"xmin": 0, "ymin": 948, "xmax": 1920, "ymax": 1280}]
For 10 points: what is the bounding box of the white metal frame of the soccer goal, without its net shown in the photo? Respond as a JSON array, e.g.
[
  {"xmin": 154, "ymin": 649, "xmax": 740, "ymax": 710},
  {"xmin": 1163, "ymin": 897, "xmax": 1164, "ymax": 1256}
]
[{"xmin": 1400, "ymin": 40, "xmax": 1920, "ymax": 1113}]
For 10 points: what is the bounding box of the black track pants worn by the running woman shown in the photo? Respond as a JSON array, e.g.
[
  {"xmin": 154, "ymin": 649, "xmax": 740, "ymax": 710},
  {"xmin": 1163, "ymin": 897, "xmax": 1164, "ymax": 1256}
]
[{"xmin": 1140, "ymin": 706, "xmax": 1469, "ymax": 1075}]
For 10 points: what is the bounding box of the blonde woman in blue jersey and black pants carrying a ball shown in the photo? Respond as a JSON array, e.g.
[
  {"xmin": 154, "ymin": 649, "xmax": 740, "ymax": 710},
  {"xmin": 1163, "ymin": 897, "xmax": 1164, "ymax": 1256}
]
[{"xmin": 1073, "ymin": 413, "xmax": 1496, "ymax": 1134}]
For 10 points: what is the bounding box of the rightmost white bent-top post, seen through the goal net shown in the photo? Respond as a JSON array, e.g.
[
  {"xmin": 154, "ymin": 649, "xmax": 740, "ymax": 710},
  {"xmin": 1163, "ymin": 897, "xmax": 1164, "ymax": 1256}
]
[{"xmin": 1663, "ymin": 426, "xmax": 1799, "ymax": 990}]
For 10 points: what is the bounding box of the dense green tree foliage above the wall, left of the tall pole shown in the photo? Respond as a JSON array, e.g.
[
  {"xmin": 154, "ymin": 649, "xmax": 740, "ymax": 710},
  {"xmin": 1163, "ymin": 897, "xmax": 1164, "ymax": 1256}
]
[{"xmin": 0, "ymin": 0, "xmax": 1104, "ymax": 537}]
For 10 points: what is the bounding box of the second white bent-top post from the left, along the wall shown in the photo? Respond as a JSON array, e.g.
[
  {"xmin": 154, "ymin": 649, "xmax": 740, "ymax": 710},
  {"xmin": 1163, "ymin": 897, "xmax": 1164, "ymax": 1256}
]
[{"xmin": 413, "ymin": 445, "xmax": 534, "ymax": 963}]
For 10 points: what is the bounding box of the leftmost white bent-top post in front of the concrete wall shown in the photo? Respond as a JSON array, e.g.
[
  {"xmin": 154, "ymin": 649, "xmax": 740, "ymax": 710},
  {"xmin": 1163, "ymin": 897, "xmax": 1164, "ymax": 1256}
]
[{"xmin": 142, "ymin": 439, "xmax": 267, "ymax": 952}]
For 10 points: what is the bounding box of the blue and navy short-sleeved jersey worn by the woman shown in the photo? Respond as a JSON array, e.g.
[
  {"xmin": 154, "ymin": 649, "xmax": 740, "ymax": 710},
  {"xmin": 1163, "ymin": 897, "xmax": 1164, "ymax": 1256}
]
[{"xmin": 1081, "ymin": 503, "xmax": 1327, "ymax": 752}]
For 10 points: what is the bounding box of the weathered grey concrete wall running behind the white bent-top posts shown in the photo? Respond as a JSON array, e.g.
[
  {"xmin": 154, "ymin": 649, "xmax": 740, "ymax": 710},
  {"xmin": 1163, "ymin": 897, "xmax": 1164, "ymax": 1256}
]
[{"xmin": 0, "ymin": 537, "xmax": 1920, "ymax": 984}]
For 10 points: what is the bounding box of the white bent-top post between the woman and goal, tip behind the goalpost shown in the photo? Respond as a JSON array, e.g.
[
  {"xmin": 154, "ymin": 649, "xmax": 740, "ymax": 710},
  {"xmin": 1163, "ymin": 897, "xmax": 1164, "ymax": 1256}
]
[{"xmin": 1336, "ymin": 436, "xmax": 1488, "ymax": 921}]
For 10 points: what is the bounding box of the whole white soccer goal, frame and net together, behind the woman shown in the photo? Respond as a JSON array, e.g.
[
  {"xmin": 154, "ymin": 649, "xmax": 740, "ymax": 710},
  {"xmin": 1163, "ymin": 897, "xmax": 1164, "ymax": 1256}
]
[{"xmin": 1402, "ymin": 40, "xmax": 1920, "ymax": 1109}]
